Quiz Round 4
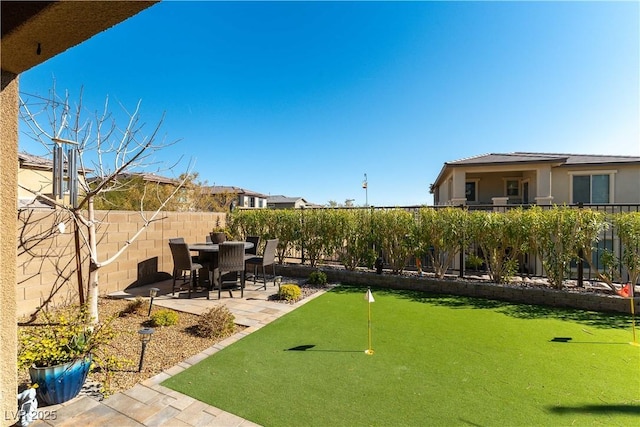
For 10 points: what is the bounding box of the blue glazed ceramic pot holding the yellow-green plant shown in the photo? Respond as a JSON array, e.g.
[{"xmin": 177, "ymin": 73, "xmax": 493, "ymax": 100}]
[{"xmin": 29, "ymin": 356, "xmax": 91, "ymax": 405}]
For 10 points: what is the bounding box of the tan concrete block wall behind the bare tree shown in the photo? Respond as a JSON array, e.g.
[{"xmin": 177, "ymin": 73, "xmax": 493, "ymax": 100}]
[{"xmin": 16, "ymin": 210, "xmax": 226, "ymax": 316}]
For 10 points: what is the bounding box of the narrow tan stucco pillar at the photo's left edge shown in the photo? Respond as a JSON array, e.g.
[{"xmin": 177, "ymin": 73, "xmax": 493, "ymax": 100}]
[{"xmin": 0, "ymin": 71, "xmax": 18, "ymax": 426}]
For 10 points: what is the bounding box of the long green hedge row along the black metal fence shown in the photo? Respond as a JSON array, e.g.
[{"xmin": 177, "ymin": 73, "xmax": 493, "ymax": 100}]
[{"xmin": 227, "ymin": 206, "xmax": 640, "ymax": 288}]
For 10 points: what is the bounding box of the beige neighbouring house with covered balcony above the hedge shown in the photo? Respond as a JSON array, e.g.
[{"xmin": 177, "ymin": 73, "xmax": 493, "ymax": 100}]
[{"xmin": 430, "ymin": 152, "xmax": 640, "ymax": 206}]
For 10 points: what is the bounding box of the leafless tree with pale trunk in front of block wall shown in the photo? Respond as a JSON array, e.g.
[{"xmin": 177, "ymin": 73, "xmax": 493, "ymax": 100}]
[{"xmin": 20, "ymin": 85, "xmax": 188, "ymax": 322}]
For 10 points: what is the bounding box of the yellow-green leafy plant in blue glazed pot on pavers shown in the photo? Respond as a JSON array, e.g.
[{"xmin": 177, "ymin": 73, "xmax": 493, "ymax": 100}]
[{"xmin": 18, "ymin": 305, "xmax": 113, "ymax": 405}]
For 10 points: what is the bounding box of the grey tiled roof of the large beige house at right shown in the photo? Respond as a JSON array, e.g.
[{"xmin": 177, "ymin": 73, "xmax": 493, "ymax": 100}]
[{"xmin": 432, "ymin": 152, "xmax": 640, "ymax": 187}]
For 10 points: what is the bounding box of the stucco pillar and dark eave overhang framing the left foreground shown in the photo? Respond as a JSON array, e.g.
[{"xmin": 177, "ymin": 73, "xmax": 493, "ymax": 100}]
[{"xmin": 0, "ymin": 0, "xmax": 157, "ymax": 426}]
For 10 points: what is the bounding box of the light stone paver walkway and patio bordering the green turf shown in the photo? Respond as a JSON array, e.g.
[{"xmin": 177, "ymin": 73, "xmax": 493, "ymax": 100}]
[{"xmin": 31, "ymin": 278, "xmax": 322, "ymax": 427}]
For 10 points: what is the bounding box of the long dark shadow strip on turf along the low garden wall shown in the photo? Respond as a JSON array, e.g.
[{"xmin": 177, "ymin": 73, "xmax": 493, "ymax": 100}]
[{"xmin": 331, "ymin": 284, "xmax": 632, "ymax": 329}]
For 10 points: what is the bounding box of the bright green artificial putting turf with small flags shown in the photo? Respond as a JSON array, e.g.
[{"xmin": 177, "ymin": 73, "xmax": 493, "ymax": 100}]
[{"xmin": 163, "ymin": 287, "xmax": 640, "ymax": 426}]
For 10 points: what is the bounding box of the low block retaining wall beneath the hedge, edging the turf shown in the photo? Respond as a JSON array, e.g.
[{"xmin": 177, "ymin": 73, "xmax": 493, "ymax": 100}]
[{"xmin": 276, "ymin": 264, "xmax": 640, "ymax": 313}]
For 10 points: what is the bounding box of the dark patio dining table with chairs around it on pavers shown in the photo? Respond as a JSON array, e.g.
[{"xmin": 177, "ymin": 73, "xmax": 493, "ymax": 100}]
[{"xmin": 169, "ymin": 233, "xmax": 278, "ymax": 299}]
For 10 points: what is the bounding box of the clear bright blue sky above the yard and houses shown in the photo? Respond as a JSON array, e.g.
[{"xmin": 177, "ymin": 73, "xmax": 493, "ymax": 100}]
[{"xmin": 20, "ymin": 1, "xmax": 640, "ymax": 206}]
